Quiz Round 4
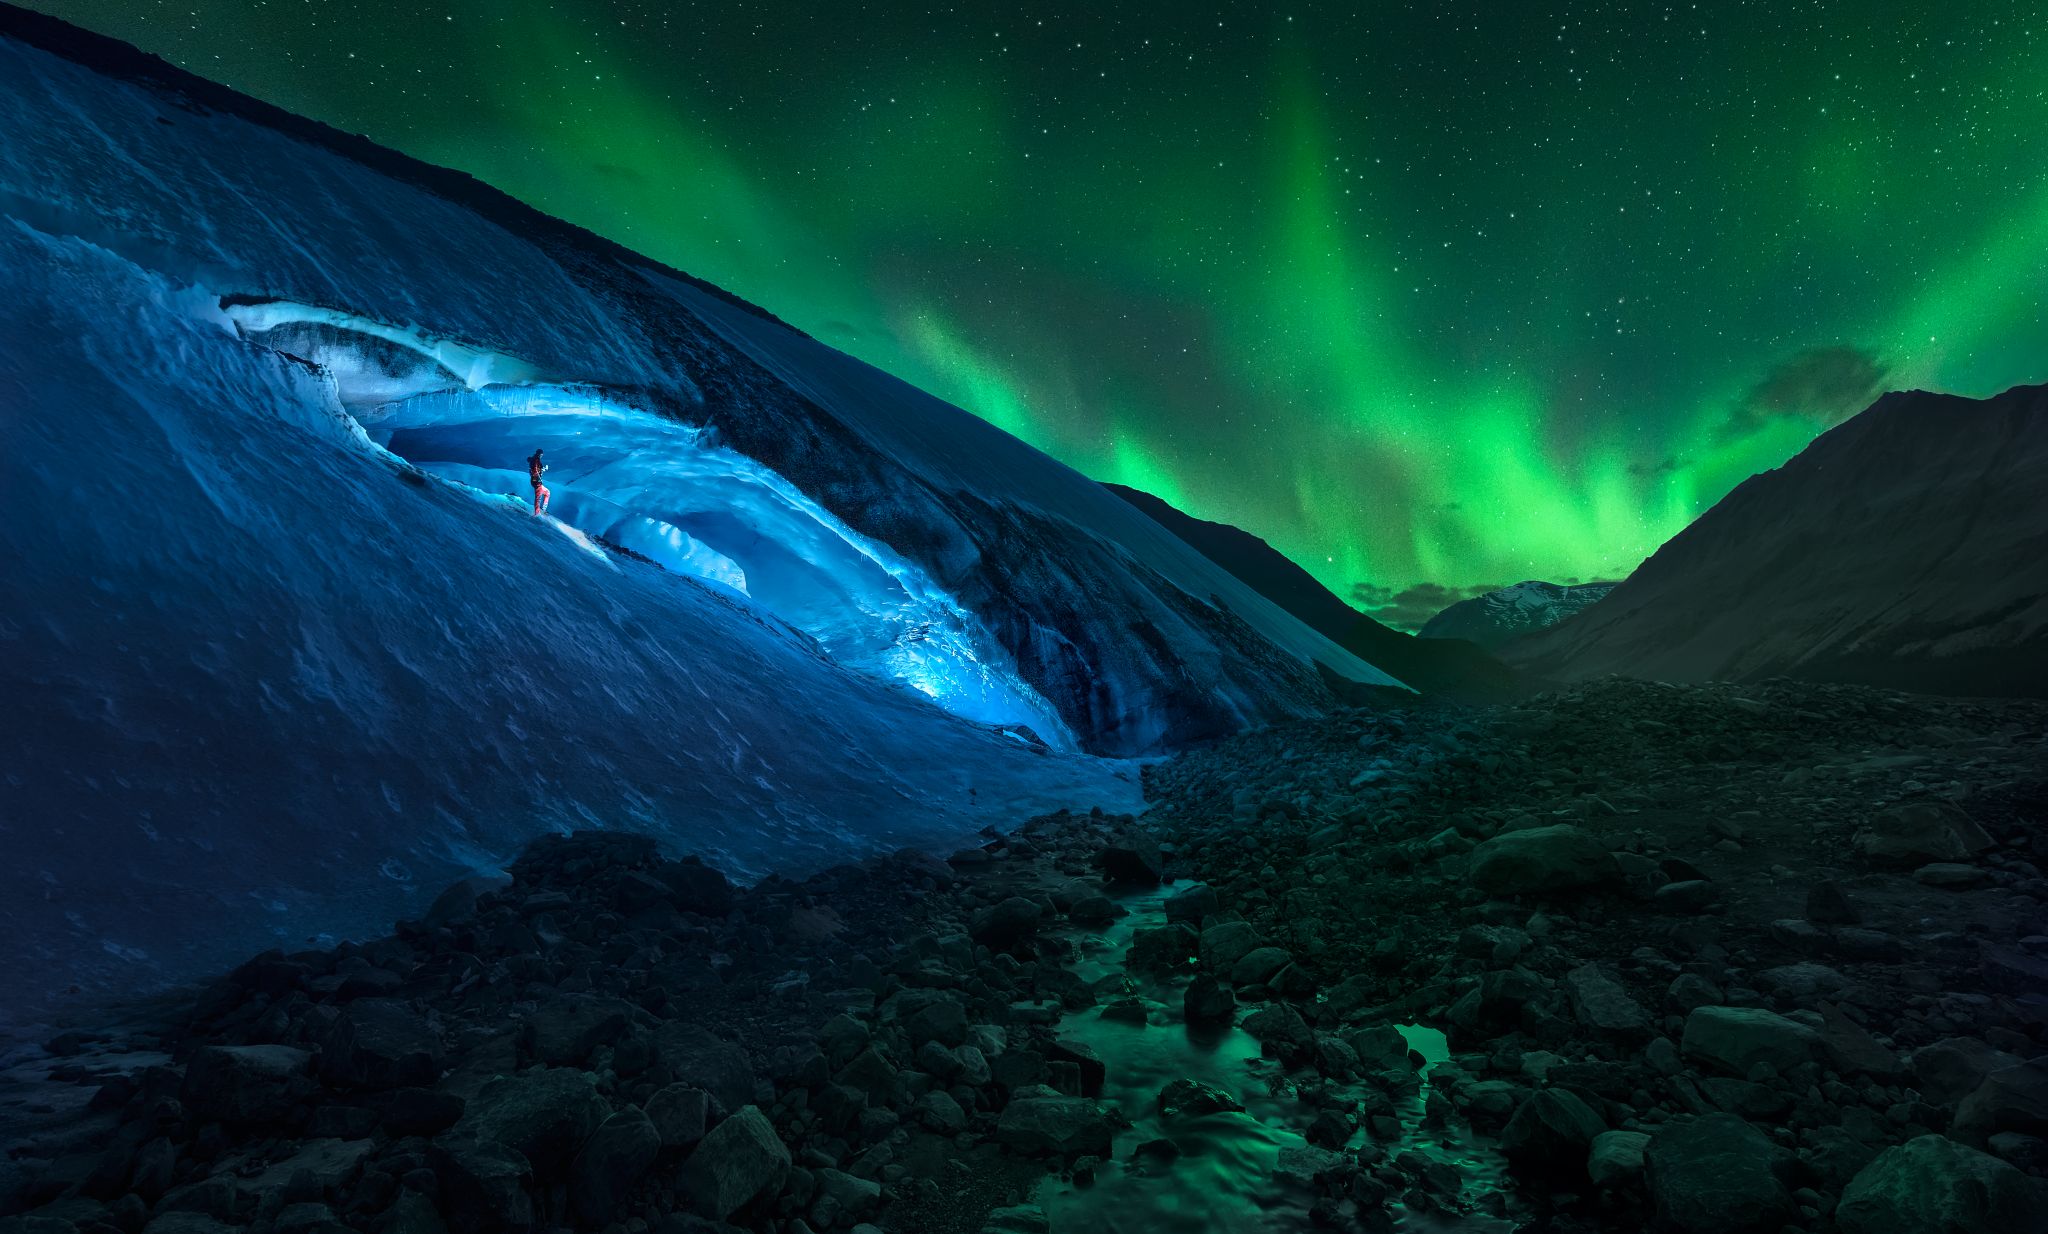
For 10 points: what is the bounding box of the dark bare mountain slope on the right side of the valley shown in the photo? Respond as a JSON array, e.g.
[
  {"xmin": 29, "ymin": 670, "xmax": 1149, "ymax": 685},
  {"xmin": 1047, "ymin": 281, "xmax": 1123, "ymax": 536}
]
[{"xmin": 1505, "ymin": 387, "xmax": 2048, "ymax": 696}]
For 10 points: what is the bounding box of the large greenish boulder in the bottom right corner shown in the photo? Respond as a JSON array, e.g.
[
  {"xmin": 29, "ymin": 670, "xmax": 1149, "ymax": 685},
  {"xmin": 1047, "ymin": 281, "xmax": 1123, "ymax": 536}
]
[{"xmin": 1835, "ymin": 1136, "xmax": 2044, "ymax": 1234}]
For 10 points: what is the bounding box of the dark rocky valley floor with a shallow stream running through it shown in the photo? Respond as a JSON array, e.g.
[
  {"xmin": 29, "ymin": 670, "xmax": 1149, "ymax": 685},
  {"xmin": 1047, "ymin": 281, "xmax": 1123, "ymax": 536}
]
[{"xmin": 0, "ymin": 681, "xmax": 2048, "ymax": 1234}]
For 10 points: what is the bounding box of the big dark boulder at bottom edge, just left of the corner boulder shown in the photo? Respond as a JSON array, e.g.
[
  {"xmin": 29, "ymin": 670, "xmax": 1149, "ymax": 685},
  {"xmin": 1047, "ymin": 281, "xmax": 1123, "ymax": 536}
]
[{"xmin": 1642, "ymin": 1113, "xmax": 1798, "ymax": 1234}]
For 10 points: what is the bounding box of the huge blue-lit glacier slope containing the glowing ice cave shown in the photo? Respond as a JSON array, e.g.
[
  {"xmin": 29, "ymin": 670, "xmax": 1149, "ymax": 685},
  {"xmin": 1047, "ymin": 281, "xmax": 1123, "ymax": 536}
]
[{"xmin": 0, "ymin": 6, "xmax": 1395, "ymax": 1017}]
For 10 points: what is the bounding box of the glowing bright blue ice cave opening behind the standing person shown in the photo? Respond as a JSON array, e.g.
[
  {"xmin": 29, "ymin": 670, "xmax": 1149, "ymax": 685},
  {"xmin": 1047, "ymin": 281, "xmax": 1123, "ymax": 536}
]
[{"xmin": 223, "ymin": 297, "xmax": 1075, "ymax": 749}]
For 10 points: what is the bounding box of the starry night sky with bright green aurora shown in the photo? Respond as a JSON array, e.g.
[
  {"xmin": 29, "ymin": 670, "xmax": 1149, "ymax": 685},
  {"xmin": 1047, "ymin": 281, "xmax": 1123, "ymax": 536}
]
[{"xmin": 39, "ymin": 0, "xmax": 2048, "ymax": 622}]
